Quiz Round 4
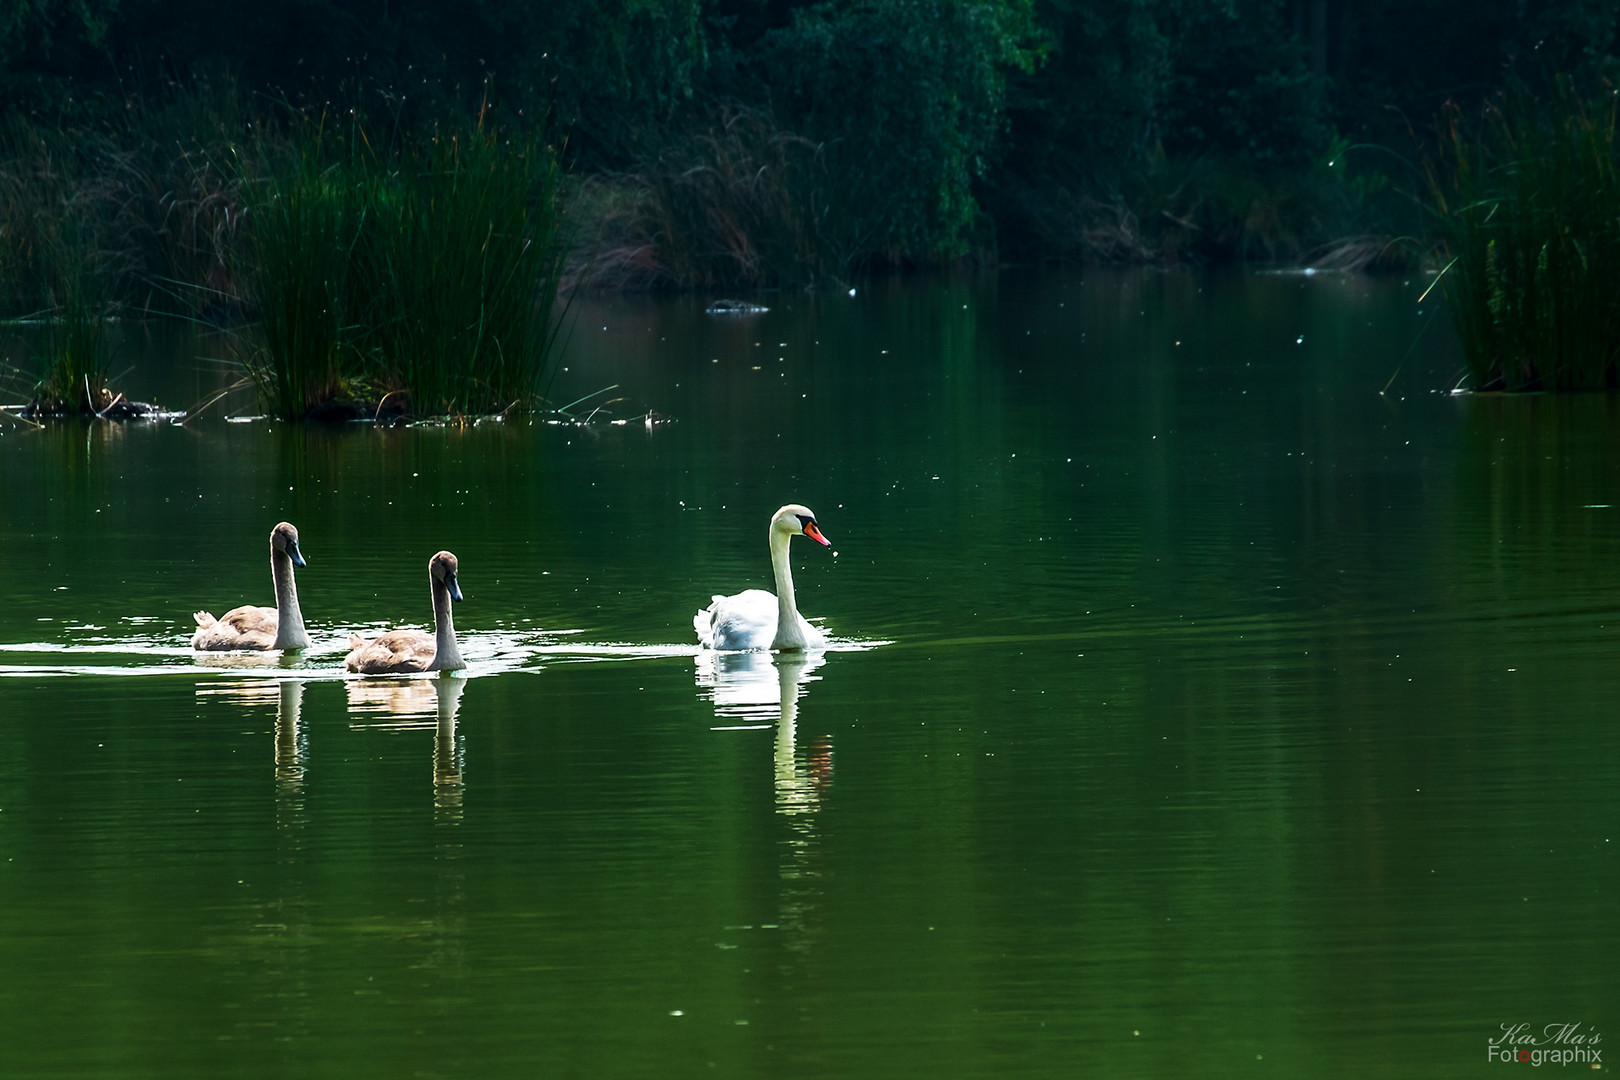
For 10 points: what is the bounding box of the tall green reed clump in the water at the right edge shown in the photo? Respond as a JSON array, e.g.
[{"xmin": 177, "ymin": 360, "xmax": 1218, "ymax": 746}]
[{"xmin": 1429, "ymin": 83, "xmax": 1620, "ymax": 390}]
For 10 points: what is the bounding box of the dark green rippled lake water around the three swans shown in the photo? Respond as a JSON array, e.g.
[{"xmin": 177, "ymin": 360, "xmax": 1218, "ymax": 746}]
[{"xmin": 0, "ymin": 272, "xmax": 1620, "ymax": 1080}]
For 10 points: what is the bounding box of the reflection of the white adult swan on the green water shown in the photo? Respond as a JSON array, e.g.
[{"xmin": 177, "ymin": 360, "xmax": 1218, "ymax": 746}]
[{"xmin": 695, "ymin": 649, "xmax": 833, "ymax": 814}]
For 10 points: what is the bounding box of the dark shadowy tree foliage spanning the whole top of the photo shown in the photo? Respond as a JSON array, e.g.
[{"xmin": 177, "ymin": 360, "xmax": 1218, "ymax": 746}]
[{"xmin": 0, "ymin": 0, "xmax": 1620, "ymax": 266}]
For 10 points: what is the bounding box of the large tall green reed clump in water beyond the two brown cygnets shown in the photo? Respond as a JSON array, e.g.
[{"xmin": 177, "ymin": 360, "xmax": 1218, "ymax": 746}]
[{"xmin": 238, "ymin": 118, "xmax": 564, "ymax": 419}]
